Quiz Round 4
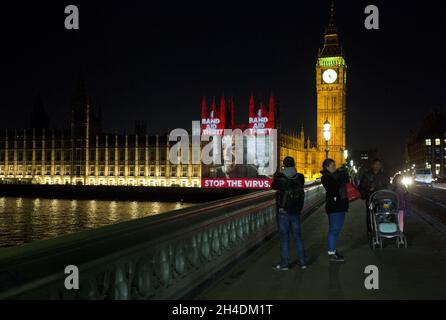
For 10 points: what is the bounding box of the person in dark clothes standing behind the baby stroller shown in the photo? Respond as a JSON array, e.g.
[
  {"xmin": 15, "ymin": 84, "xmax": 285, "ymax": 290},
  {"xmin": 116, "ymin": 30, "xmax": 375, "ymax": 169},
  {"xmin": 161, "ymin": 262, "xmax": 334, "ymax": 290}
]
[{"xmin": 359, "ymin": 159, "xmax": 389, "ymax": 236}]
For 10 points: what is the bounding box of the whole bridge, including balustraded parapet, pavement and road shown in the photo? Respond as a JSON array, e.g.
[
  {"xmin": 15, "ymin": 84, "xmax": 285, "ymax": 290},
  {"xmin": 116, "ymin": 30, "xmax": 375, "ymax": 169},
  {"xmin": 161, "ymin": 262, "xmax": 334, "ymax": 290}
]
[{"xmin": 0, "ymin": 185, "xmax": 446, "ymax": 300}]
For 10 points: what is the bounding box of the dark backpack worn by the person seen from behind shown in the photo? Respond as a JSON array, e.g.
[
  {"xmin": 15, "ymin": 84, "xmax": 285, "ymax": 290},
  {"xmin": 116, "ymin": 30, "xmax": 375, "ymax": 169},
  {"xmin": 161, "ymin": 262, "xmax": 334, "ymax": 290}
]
[{"xmin": 277, "ymin": 175, "xmax": 305, "ymax": 213}]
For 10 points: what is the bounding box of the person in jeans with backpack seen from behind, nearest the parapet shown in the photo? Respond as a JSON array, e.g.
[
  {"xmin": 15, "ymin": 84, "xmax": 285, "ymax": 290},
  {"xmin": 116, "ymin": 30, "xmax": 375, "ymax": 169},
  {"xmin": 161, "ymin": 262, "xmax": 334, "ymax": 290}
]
[{"xmin": 272, "ymin": 157, "xmax": 307, "ymax": 270}]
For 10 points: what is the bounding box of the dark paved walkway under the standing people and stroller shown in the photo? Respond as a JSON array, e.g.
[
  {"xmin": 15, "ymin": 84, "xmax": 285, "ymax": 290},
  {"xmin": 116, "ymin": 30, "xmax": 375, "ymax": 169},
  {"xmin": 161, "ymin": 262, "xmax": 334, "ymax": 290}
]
[{"xmin": 197, "ymin": 201, "xmax": 446, "ymax": 300}]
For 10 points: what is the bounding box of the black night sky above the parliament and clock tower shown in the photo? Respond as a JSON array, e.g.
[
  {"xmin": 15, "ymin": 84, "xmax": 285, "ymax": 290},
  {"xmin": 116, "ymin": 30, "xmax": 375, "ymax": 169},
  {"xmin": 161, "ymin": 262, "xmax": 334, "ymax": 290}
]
[{"xmin": 0, "ymin": 0, "xmax": 446, "ymax": 169}]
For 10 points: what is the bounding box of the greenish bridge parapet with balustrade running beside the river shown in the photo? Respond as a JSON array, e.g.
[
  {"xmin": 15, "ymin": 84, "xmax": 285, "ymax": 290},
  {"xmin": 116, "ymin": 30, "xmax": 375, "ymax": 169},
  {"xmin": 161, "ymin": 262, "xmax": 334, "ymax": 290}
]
[{"xmin": 0, "ymin": 185, "xmax": 325, "ymax": 300}]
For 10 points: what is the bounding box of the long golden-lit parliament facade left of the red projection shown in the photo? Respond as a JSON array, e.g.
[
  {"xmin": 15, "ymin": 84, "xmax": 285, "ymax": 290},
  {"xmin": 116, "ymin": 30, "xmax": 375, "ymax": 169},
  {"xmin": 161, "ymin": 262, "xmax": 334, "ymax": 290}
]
[{"xmin": 0, "ymin": 83, "xmax": 201, "ymax": 187}]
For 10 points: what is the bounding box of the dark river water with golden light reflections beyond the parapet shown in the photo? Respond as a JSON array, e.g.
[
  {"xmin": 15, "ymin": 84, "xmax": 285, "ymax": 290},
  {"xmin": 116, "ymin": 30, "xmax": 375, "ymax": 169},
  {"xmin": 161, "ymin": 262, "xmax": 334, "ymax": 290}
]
[{"xmin": 0, "ymin": 197, "xmax": 194, "ymax": 248}]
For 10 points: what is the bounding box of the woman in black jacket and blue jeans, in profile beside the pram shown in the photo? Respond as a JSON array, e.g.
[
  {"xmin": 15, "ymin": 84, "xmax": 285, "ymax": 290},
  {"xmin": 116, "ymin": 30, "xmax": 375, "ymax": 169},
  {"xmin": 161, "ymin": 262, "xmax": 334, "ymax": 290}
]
[{"xmin": 321, "ymin": 159, "xmax": 349, "ymax": 261}]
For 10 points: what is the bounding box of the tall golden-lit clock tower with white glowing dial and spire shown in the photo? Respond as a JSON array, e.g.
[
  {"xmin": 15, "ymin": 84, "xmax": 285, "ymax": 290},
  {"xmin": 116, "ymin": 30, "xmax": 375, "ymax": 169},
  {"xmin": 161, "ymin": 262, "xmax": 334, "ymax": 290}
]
[{"xmin": 316, "ymin": 3, "xmax": 347, "ymax": 166}]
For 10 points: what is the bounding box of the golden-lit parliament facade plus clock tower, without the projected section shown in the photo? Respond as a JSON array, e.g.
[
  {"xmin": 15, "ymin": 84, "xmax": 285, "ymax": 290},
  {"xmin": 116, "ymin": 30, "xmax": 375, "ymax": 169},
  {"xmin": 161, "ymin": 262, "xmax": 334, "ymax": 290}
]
[{"xmin": 0, "ymin": 2, "xmax": 347, "ymax": 187}]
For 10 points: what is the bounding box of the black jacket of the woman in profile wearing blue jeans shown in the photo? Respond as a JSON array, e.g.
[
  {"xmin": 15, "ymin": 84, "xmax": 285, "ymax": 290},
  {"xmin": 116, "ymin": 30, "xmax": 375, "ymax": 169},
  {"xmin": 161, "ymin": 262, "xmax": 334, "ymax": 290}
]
[{"xmin": 321, "ymin": 170, "xmax": 349, "ymax": 214}]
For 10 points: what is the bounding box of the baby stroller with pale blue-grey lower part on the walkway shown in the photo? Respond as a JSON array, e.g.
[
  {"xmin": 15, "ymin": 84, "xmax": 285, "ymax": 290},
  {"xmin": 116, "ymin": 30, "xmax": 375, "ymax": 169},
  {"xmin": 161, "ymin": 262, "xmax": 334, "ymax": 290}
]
[{"xmin": 369, "ymin": 190, "xmax": 407, "ymax": 249}]
